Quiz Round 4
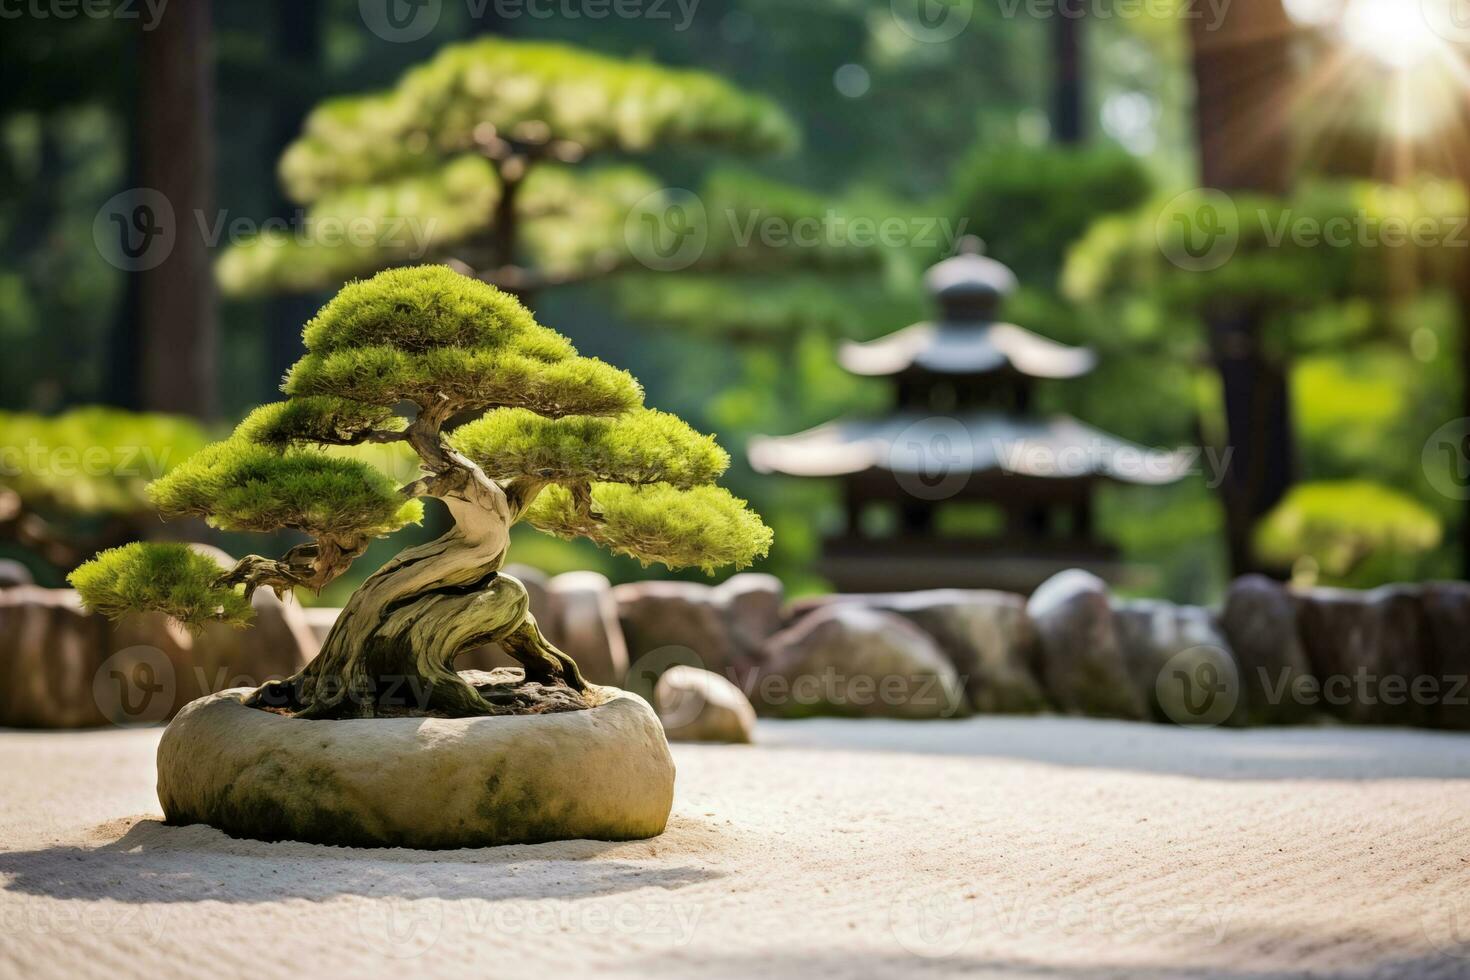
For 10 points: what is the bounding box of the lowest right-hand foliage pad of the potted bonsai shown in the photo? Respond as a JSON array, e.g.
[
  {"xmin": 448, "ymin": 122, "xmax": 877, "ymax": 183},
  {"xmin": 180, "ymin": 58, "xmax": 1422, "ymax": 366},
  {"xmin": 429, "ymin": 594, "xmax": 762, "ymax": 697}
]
[{"xmin": 526, "ymin": 483, "xmax": 772, "ymax": 573}]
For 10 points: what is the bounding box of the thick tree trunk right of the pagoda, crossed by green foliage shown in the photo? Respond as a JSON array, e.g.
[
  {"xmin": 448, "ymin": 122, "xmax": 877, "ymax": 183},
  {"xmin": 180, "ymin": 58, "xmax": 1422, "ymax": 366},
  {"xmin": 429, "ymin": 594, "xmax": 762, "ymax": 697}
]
[{"xmin": 1189, "ymin": 0, "xmax": 1295, "ymax": 574}]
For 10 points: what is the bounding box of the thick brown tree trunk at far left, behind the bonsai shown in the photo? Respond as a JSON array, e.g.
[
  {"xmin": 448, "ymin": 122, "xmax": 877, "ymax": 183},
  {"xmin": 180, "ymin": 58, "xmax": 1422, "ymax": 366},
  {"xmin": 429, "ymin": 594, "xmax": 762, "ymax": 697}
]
[{"xmin": 134, "ymin": 0, "xmax": 216, "ymax": 419}]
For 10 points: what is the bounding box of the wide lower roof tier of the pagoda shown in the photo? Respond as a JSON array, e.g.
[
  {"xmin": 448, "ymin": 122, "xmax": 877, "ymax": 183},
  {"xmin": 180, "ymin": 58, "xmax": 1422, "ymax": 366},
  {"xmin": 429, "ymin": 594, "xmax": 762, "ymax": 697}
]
[{"xmin": 748, "ymin": 411, "xmax": 1192, "ymax": 486}]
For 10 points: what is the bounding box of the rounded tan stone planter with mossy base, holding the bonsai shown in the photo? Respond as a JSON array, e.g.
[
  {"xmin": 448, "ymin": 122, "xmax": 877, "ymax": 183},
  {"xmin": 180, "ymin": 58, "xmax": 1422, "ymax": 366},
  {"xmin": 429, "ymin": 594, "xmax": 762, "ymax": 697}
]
[{"xmin": 159, "ymin": 688, "xmax": 673, "ymax": 848}]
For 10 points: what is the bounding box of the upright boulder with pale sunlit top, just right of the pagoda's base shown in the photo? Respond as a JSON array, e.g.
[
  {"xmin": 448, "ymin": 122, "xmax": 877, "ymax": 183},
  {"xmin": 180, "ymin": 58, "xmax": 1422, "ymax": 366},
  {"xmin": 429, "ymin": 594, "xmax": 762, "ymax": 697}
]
[{"xmin": 1026, "ymin": 569, "xmax": 1147, "ymax": 720}]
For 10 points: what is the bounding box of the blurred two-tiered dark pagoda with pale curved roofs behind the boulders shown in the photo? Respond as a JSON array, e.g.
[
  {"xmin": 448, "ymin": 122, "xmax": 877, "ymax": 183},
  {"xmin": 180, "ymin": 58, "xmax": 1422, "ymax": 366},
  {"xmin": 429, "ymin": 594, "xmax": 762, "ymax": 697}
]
[{"xmin": 750, "ymin": 238, "xmax": 1189, "ymax": 592}]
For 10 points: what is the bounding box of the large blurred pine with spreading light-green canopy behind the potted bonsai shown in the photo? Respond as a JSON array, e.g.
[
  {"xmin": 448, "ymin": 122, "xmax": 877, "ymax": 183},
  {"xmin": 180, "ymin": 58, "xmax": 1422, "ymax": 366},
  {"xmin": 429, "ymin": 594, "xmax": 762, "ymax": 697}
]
[{"xmin": 219, "ymin": 38, "xmax": 795, "ymax": 297}]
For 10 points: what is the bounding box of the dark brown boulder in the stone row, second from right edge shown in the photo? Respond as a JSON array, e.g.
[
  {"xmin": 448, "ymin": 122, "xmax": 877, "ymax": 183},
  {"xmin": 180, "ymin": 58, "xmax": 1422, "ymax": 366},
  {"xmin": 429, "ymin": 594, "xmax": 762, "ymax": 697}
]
[{"xmin": 1297, "ymin": 586, "xmax": 1444, "ymax": 724}]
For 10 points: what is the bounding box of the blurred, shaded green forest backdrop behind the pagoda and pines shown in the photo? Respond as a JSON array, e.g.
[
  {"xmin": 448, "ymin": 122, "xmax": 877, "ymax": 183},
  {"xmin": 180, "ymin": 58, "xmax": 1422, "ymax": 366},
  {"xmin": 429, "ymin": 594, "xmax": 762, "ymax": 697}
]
[{"xmin": 0, "ymin": 0, "xmax": 1470, "ymax": 601}]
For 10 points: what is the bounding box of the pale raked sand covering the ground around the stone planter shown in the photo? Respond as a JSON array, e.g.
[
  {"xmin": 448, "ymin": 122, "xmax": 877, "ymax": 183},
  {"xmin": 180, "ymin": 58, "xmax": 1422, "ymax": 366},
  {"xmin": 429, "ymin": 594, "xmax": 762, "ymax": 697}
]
[{"xmin": 0, "ymin": 718, "xmax": 1470, "ymax": 980}]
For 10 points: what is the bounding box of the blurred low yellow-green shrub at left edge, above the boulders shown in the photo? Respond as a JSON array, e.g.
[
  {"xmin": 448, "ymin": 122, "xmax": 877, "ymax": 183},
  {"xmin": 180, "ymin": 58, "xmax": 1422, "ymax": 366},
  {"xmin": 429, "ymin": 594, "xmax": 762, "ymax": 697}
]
[{"xmin": 0, "ymin": 406, "xmax": 206, "ymax": 573}]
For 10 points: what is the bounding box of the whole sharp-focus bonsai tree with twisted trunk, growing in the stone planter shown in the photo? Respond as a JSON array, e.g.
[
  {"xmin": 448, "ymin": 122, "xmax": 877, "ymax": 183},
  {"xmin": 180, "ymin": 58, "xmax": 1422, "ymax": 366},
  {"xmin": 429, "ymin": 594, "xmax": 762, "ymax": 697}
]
[{"xmin": 72, "ymin": 266, "xmax": 770, "ymax": 718}]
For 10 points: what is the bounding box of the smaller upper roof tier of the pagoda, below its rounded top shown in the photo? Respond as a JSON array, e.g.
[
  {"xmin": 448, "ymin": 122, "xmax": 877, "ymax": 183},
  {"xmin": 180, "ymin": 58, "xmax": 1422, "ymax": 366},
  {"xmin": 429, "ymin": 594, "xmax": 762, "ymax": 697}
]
[{"xmin": 838, "ymin": 322, "xmax": 1097, "ymax": 381}]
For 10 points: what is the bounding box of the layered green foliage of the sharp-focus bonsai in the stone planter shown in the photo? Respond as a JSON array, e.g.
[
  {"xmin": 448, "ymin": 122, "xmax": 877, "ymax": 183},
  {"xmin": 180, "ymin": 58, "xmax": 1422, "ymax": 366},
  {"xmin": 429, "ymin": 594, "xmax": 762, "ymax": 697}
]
[{"xmin": 72, "ymin": 266, "xmax": 772, "ymax": 624}]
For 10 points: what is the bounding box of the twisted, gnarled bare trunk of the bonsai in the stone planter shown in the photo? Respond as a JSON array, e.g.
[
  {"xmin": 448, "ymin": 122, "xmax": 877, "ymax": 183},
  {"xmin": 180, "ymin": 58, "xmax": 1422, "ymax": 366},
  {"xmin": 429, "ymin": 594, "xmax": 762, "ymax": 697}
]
[{"xmin": 248, "ymin": 420, "xmax": 587, "ymax": 718}]
